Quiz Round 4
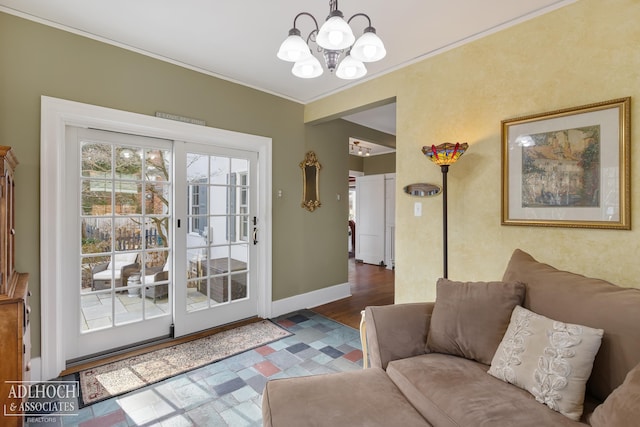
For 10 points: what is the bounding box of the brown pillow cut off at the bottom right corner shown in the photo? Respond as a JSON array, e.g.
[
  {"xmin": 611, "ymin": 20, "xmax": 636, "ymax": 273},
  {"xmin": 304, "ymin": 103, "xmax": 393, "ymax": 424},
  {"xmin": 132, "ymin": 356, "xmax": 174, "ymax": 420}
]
[{"xmin": 589, "ymin": 365, "xmax": 640, "ymax": 427}]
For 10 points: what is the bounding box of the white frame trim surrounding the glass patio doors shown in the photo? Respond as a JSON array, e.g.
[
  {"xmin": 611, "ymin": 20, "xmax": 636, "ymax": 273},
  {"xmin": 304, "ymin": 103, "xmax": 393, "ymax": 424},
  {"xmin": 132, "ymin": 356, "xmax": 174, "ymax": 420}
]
[{"xmin": 40, "ymin": 96, "xmax": 272, "ymax": 379}]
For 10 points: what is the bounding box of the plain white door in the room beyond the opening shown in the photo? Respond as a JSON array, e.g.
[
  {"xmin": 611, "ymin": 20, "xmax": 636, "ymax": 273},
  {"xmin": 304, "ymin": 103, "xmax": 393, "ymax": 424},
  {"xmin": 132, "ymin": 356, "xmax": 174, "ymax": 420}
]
[{"xmin": 356, "ymin": 175, "xmax": 385, "ymax": 265}]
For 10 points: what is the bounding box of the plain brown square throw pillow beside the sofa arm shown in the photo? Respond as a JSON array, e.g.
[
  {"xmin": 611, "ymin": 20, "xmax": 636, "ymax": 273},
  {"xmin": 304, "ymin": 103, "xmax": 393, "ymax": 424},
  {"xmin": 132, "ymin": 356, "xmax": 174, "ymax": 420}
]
[{"xmin": 426, "ymin": 279, "xmax": 525, "ymax": 365}]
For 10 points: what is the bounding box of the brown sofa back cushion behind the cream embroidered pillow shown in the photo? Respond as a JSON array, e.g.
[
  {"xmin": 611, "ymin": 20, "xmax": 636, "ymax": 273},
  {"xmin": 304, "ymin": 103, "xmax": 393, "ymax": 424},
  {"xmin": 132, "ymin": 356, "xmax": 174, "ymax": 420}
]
[{"xmin": 503, "ymin": 249, "xmax": 640, "ymax": 401}]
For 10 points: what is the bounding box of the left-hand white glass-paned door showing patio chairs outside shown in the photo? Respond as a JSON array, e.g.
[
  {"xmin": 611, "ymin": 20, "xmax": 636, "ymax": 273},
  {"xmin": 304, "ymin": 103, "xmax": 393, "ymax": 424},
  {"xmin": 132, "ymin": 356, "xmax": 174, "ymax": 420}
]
[{"xmin": 61, "ymin": 127, "xmax": 173, "ymax": 361}]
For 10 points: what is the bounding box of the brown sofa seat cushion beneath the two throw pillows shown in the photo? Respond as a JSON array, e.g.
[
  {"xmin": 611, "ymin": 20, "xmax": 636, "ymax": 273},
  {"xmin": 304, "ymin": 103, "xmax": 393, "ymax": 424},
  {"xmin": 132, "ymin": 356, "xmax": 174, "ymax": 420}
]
[{"xmin": 387, "ymin": 353, "xmax": 584, "ymax": 427}]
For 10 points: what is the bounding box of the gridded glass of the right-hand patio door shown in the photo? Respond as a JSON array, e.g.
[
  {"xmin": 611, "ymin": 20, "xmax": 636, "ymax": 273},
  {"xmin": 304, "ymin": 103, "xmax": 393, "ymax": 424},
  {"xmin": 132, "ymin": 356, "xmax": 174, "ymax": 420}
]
[{"xmin": 187, "ymin": 154, "xmax": 250, "ymax": 311}]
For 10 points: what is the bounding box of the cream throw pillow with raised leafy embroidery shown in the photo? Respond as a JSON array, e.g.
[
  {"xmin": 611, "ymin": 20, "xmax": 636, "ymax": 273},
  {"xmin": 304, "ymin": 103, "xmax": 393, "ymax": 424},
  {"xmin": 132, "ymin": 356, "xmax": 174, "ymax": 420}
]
[{"xmin": 489, "ymin": 307, "xmax": 603, "ymax": 421}]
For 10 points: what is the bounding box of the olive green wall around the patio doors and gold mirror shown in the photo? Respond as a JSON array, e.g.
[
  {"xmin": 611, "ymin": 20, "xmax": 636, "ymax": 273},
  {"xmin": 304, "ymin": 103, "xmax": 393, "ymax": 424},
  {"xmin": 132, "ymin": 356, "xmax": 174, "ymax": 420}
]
[{"xmin": 0, "ymin": 13, "xmax": 372, "ymax": 357}]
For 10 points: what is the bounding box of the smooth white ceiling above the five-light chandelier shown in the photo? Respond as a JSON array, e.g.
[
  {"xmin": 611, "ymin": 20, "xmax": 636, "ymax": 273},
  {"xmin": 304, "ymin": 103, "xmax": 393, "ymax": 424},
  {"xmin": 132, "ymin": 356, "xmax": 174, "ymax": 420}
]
[{"xmin": 0, "ymin": 0, "xmax": 577, "ymax": 108}]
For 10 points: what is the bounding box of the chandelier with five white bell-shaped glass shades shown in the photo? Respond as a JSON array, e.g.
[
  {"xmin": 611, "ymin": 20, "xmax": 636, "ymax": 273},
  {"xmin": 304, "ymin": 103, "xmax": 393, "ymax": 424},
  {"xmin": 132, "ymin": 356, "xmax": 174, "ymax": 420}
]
[{"xmin": 278, "ymin": 0, "xmax": 387, "ymax": 80}]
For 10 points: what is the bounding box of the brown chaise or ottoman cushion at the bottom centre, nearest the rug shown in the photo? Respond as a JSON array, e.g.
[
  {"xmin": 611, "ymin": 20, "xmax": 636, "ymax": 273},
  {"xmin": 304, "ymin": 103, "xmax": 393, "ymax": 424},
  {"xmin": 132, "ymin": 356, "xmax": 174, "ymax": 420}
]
[{"xmin": 262, "ymin": 368, "xmax": 431, "ymax": 427}]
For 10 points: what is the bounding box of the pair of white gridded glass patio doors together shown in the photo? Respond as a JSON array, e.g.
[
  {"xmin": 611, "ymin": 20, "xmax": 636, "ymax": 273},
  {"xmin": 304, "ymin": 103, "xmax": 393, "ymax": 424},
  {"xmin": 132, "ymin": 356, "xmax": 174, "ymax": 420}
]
[{"xmin": 63, "ymin": 127, "xmax": 257, "ymax": 361}]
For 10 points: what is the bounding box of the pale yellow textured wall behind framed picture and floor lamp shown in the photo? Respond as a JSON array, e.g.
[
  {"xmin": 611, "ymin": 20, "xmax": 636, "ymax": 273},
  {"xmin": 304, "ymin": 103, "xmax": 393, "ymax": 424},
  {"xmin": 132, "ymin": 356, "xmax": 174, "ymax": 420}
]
[{"xmin": 305, "ymin": 0, "xmax": 640, "ymax": 302}]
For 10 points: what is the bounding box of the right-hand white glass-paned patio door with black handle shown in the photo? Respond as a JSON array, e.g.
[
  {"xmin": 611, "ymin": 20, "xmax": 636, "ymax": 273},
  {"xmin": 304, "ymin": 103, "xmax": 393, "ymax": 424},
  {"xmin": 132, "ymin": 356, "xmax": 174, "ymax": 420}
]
[{"xmin": 175, "ymin": 143, "xmax": 259, "ymax": 336}]
